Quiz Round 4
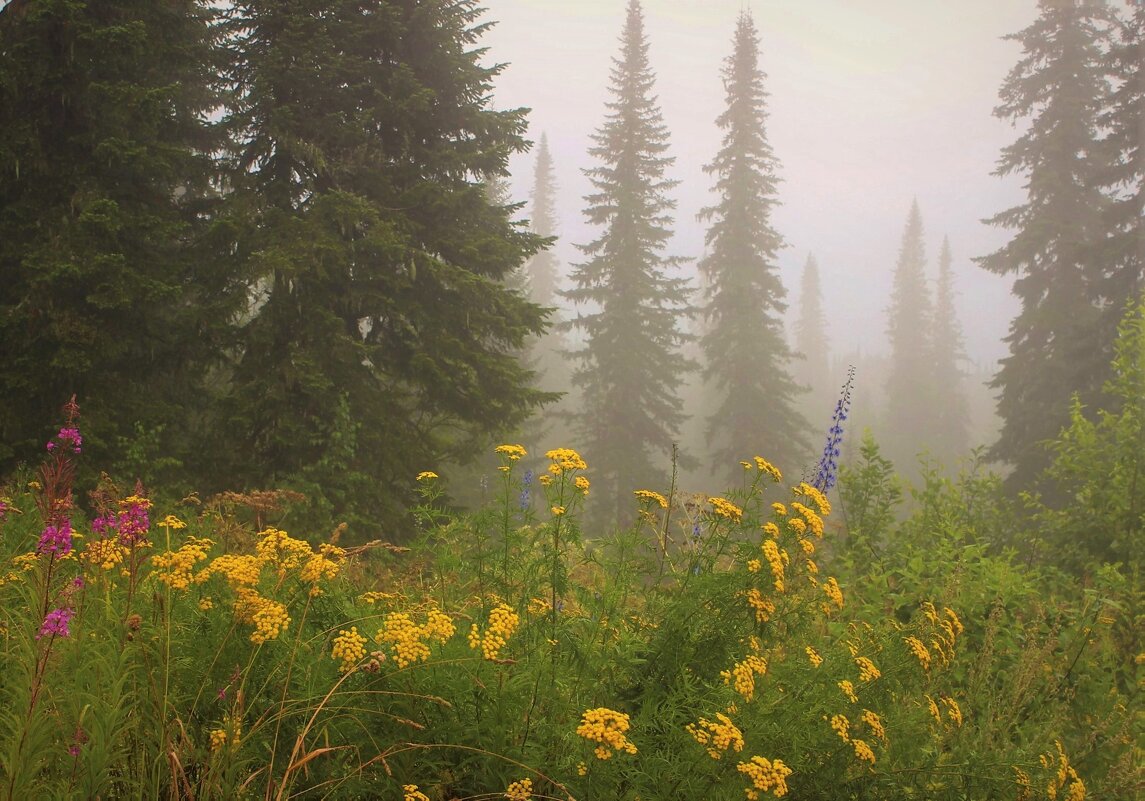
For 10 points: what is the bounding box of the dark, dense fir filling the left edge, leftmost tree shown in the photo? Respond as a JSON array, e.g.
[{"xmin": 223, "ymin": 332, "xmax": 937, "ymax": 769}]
[{"xmin": 0, "ymin": 0, "xmax": 242, "ymax": 478}]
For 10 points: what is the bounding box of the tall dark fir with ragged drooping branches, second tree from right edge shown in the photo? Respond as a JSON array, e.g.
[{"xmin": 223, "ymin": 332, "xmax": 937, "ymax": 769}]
[{"xmin": 979, "ymin": 0, "xmax": 1124, "ymax": 487}]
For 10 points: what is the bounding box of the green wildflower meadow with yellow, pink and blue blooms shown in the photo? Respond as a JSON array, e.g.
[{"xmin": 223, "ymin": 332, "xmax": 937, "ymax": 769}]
[{"xmin": 0, "ymin": 329, "xmax": 1145, "ymax": 801}]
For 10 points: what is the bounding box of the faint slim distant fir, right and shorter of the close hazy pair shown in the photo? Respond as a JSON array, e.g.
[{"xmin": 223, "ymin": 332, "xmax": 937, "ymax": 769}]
[{"xmin": 929, "ymin": 237, "xmax": 973, "ymax": 467}]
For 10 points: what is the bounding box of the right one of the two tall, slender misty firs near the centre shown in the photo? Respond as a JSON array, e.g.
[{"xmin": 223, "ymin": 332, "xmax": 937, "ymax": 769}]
[{"xmin": 700, "ymin": 11, "xmax": 808, "ymax": 482}]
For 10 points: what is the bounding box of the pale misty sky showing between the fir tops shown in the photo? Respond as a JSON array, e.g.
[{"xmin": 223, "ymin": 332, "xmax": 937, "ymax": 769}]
[{"xmin": 483, "ymin": 0, "xmax": 1036, "ymax": 368}]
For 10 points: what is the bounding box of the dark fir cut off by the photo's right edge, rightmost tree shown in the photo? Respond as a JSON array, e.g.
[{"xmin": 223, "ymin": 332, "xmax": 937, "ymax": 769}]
[{"xmin": 1101, "ymin": 2, "xmax": 1145, "ymax": 339}]
